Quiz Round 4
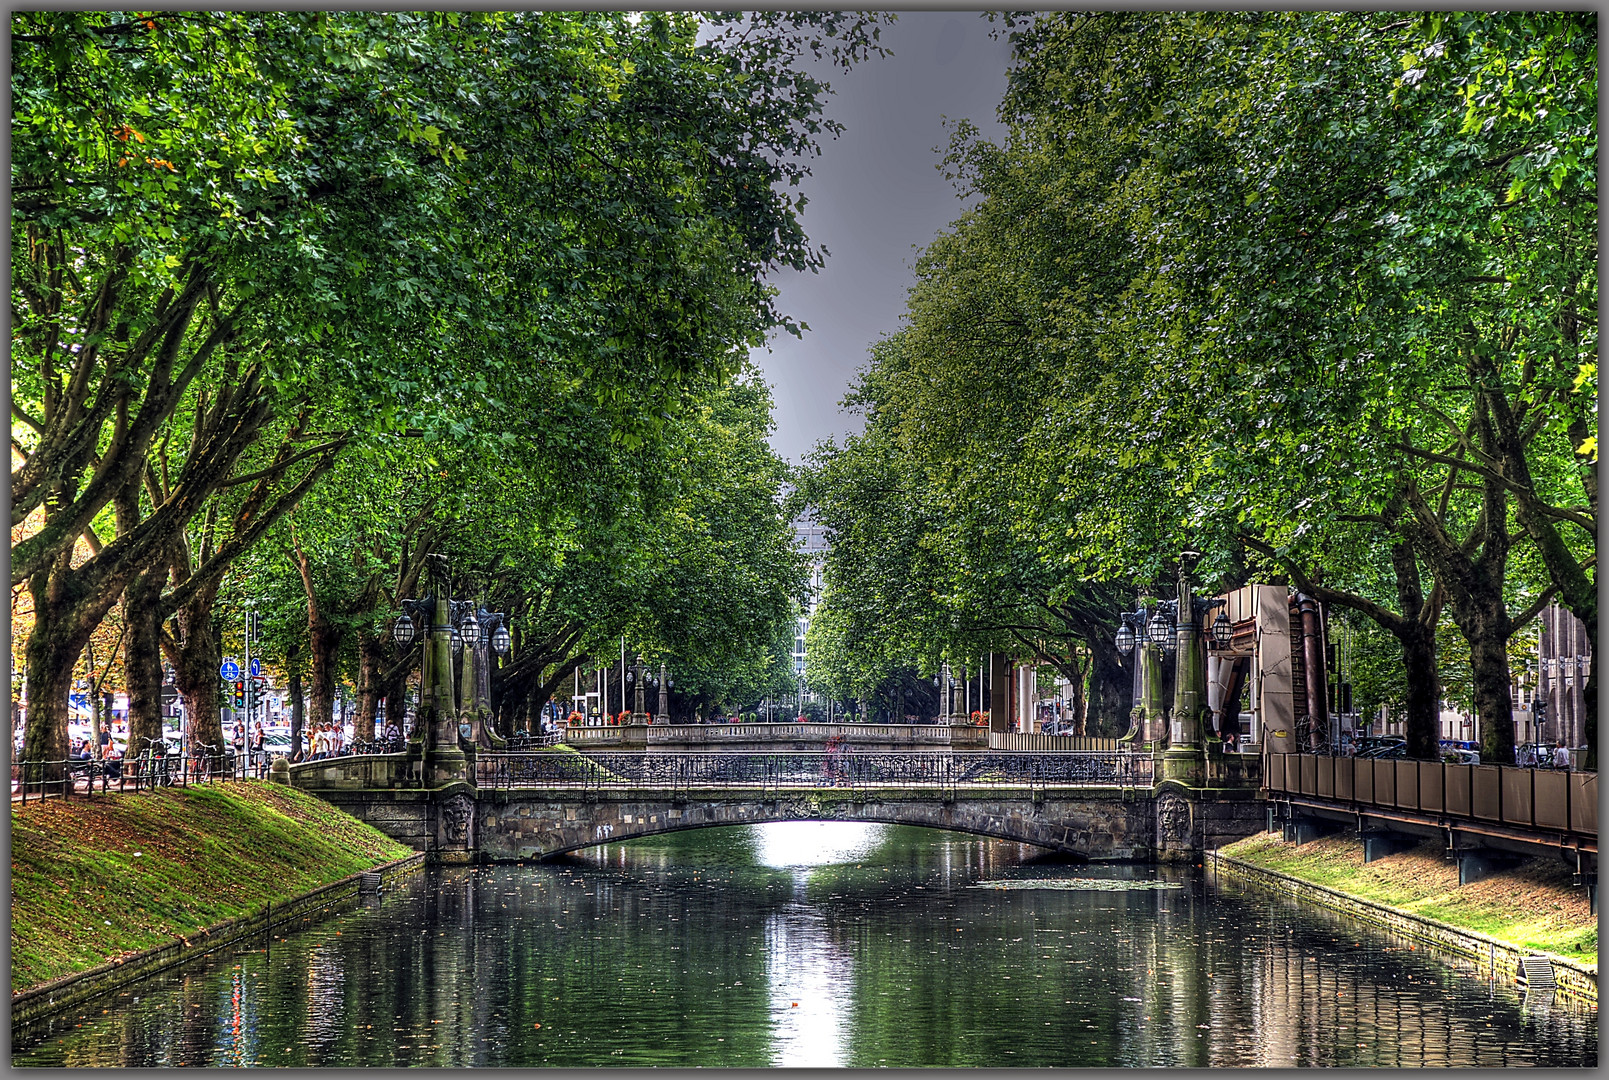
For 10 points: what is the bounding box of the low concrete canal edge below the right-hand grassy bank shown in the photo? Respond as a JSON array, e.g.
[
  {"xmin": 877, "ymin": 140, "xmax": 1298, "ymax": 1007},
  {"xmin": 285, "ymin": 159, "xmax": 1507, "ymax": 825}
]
[{"xmin": 1207, "ymin": 851, "xmax": 1598, "ymax": 1008}]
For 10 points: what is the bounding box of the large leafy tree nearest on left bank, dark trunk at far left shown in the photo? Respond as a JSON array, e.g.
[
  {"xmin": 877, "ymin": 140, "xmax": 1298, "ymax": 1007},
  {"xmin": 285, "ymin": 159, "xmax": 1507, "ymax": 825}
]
[{"xmin": 13, "ymin": 13, "xmax": 894, "ymax": 756}]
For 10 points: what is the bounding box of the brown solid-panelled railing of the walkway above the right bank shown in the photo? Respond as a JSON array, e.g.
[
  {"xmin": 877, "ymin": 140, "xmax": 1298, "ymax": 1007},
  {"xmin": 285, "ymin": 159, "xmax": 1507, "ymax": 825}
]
[{"xmin": 1266, "ymin": 753, "xmax": 1598, "ymax": 840}]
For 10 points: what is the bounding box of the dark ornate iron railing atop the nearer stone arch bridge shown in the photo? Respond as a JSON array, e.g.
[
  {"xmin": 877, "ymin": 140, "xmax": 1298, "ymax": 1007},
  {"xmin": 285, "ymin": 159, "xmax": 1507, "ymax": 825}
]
[{"xmin": 475, "ymin": 750, "xmax": 1152, "ymax": 790}]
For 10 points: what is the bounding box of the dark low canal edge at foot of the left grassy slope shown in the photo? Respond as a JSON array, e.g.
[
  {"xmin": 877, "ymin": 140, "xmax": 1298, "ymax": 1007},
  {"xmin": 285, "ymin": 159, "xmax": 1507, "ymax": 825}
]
[{"xmin": 11, "ymin": 851, "xmax": 425, "ymax": 1037}]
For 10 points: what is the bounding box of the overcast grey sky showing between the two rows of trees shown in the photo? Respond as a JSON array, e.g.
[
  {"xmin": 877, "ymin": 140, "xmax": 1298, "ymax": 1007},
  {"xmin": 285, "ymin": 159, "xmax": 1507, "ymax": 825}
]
[{"xmin": 753, "ymin": 11, "xmax": 1010, "ymax": 464}]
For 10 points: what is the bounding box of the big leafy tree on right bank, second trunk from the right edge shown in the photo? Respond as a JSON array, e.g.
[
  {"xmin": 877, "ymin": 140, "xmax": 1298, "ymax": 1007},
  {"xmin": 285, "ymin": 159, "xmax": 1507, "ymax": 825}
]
[{"xmin": 954, "ymin": 14, "xmax": 1591, "ymax": 760}]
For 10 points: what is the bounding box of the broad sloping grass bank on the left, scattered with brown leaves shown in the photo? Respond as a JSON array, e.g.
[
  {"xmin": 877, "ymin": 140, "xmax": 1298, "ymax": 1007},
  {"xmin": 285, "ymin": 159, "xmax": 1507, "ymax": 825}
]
[{"xmin": 11, "ymin": 782, "xmax": 410, "ymax": 991}]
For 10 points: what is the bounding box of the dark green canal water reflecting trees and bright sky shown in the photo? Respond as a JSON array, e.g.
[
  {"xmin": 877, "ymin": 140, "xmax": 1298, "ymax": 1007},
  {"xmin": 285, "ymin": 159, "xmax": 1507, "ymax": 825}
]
[{"xmin": 11, "ymin": 822, "xmax": 1598, "ymax": 1067}]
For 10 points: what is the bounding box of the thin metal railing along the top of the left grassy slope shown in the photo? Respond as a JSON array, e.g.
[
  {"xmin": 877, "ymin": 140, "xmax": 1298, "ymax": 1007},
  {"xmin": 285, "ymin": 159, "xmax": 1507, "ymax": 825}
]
[{"xmin": 11, "ymin": 742, "xmax": 254, "ymax": 803}]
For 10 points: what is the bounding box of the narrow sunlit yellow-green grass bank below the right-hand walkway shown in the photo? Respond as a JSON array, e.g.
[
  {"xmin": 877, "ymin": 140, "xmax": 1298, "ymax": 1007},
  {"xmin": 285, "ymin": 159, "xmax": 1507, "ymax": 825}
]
[{"xmin": 1220, "ymin": 832, "xmax": 1598, "ymax": 964}]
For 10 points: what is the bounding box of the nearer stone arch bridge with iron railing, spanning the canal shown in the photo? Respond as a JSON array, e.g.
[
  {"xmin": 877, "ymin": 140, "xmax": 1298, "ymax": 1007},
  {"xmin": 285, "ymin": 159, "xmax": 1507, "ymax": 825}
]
[{"xmin": 288, "ymin": 753, "xmax": 1265, "ymax": 863}]
